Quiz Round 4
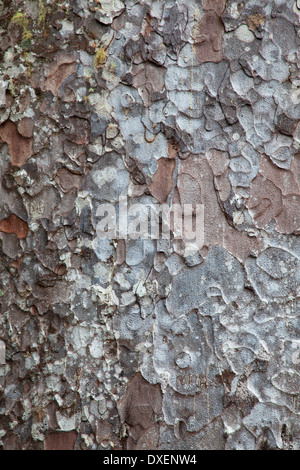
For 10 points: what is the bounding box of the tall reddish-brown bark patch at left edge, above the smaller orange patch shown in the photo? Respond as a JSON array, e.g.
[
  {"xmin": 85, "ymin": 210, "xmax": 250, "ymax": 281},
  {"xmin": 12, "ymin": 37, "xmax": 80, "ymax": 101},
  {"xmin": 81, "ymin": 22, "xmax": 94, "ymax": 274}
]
[{"xmin": 0, "ymin": 121, "xmax": 33, "ymax": 167}]
